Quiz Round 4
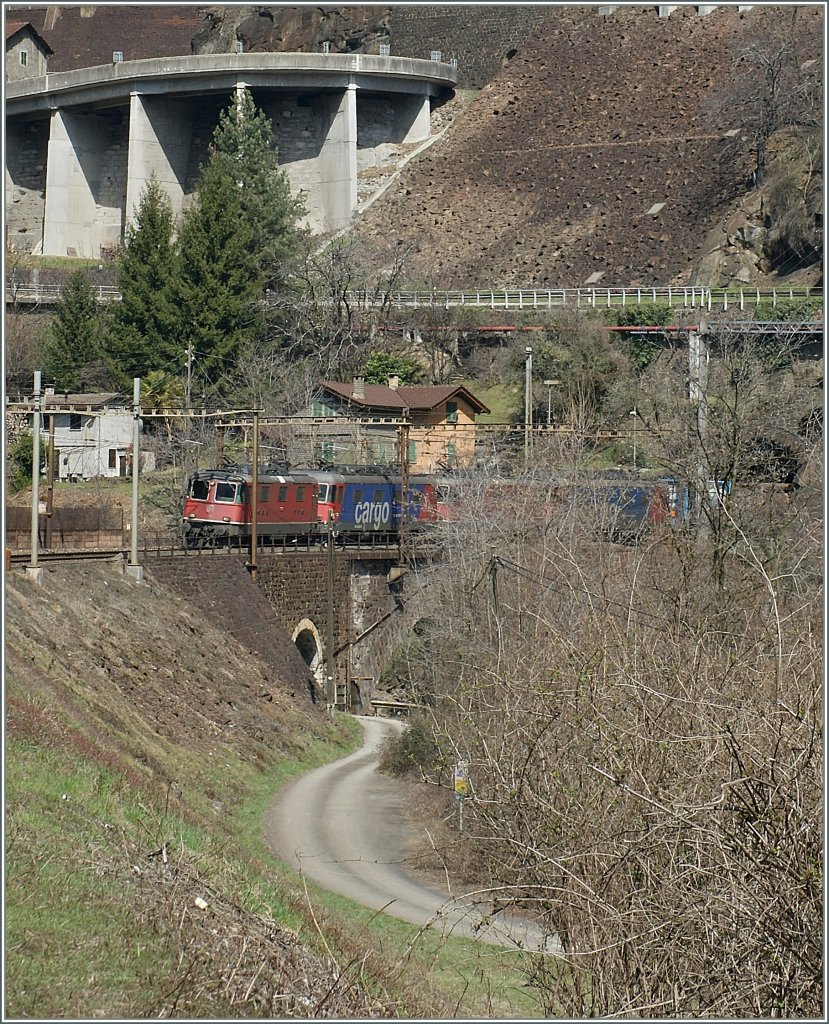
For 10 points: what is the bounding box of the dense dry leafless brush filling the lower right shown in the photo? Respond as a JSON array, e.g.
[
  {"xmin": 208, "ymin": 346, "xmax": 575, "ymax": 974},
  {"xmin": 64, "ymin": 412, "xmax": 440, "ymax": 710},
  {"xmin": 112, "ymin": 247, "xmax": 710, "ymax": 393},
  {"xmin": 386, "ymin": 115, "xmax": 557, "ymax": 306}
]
[{"xmin": 378, "ymin": 339, "xmax": 823, "ymax": 1018}]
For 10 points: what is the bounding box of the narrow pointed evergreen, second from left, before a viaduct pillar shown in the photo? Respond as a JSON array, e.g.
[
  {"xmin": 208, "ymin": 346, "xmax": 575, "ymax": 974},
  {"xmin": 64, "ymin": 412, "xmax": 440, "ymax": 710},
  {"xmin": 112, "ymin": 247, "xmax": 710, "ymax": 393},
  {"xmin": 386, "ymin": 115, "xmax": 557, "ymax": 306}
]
[{"xmin": 107, "ymin": 176, "xmax": 181, "ymax": 380}]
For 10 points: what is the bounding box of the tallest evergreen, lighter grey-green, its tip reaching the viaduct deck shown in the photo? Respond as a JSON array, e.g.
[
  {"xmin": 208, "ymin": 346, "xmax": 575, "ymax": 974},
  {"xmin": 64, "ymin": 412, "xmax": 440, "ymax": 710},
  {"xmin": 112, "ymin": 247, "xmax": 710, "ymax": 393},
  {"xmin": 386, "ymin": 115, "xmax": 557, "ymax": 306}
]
[{"xmin": 212, "ymin": 89, "xmax": 305, "ymax": 289}]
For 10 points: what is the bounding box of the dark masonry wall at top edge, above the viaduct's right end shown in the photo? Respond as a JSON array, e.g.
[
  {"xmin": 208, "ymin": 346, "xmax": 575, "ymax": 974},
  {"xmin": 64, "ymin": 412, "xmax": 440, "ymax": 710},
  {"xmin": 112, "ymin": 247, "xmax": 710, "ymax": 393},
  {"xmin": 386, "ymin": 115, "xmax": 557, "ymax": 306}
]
[{"xmin": 389, "ymin": 4, "xmax": 558, "ymax": 89}]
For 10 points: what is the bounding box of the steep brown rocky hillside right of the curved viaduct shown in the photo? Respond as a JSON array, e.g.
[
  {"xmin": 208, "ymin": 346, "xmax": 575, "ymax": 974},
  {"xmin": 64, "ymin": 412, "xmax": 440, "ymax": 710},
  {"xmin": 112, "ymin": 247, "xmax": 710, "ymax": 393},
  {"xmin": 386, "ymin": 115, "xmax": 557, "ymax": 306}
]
[{"xmin": 354, "ymin": 7, "xmax": 822, "ymax": 288}]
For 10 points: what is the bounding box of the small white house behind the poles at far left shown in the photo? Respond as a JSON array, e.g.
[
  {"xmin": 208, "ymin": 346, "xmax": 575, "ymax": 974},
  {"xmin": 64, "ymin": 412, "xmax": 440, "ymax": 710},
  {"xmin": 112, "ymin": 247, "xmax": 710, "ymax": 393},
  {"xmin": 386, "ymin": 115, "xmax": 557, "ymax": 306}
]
[{"xmin": 42, "ymin": 388, "xmax": 156, "ymax": 480}]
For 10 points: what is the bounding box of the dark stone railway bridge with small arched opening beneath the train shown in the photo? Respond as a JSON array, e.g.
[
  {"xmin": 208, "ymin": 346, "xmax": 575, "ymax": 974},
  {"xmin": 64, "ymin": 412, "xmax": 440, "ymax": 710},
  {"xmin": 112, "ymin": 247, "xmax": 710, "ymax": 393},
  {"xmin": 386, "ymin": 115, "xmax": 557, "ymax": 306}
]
[{"xmin": 144, "ymin": 550, "xmax": 406, "ymax": 710}]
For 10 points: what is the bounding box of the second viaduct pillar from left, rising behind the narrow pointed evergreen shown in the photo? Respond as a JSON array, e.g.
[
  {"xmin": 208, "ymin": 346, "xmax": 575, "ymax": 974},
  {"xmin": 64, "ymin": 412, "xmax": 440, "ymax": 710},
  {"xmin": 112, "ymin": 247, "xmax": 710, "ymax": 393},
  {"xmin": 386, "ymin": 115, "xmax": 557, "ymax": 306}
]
[{"xmin": 126, "ymin": 92, "xmax": 192, "ymax": 227}]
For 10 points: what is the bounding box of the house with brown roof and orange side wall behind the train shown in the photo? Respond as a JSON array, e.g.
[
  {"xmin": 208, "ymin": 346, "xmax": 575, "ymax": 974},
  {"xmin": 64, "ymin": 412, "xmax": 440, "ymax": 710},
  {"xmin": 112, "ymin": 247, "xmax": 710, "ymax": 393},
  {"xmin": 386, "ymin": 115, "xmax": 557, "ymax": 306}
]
[{"xmin": 300, "ymin": 377, "xmax": 489, "ymax": 473}]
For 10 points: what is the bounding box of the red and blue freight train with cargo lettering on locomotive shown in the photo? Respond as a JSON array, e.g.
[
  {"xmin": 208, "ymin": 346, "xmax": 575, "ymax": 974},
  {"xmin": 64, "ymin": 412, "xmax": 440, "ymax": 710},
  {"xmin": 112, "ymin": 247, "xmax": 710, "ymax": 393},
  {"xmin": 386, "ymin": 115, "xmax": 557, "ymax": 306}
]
[{"xmin": 182, "ymin": 466, "xmax": 689, "ymax": 548}]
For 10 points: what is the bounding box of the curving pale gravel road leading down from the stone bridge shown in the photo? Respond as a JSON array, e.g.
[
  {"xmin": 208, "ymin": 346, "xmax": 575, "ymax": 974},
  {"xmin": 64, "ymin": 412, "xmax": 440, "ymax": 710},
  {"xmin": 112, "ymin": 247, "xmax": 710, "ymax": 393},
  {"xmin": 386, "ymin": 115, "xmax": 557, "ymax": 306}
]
[{"xmin": 264, "ymin": 718, "xmax": 557, "ymax": 952}]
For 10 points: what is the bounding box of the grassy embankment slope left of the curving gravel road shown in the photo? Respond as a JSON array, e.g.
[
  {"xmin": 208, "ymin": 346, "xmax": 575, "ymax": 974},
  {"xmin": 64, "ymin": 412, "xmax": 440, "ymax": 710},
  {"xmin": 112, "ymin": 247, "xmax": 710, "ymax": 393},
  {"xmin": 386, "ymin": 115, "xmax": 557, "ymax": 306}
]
[{"xmin": 5, "ymin": 565, "xmax": 535, "ymax": 1019}]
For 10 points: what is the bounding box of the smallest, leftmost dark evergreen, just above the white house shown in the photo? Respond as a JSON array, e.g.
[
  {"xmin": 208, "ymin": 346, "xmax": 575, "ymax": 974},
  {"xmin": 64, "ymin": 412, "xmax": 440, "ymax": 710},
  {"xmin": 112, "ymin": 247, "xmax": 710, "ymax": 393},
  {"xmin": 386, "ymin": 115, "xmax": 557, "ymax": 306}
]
[{"xmin": 45, "ymin": 270, "xmax": 106, "ymax": 391}]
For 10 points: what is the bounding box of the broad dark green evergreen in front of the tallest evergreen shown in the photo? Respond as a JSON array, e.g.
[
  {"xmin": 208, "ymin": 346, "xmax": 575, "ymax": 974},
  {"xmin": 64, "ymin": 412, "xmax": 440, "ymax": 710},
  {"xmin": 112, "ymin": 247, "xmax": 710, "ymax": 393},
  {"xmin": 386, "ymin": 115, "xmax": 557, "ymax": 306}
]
[{"xmin": 175, "ymin": 158, "xmax": 264, "ymax": 381}]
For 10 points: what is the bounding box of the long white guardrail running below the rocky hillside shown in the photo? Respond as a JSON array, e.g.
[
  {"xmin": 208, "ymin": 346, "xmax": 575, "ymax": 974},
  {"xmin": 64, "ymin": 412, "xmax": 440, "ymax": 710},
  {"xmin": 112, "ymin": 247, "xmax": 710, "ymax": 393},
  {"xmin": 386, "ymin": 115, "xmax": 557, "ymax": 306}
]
[{"xmin": 5, "ymin": 282, "xmax": 822, "ymax": 309}]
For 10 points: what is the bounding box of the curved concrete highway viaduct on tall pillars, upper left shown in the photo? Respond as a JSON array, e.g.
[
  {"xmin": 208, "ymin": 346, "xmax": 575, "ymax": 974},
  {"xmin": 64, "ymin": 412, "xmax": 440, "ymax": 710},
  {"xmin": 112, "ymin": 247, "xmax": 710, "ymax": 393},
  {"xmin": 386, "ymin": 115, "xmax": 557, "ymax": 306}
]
[{"xmin": 5, "ymin": 53, "xmax": 457, "ymax": 258}]
